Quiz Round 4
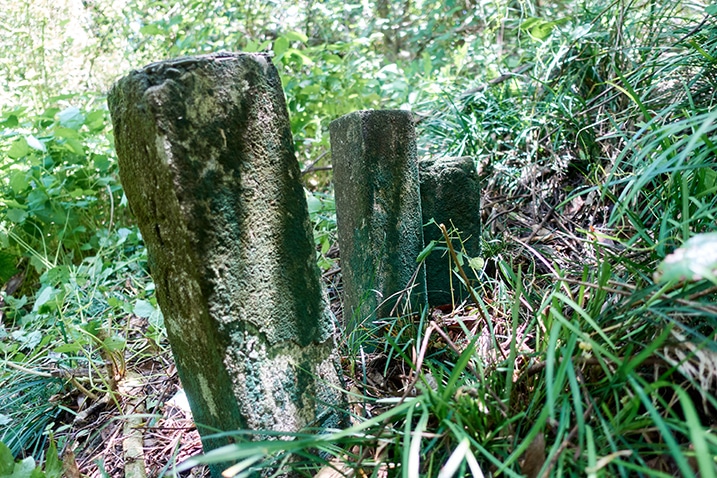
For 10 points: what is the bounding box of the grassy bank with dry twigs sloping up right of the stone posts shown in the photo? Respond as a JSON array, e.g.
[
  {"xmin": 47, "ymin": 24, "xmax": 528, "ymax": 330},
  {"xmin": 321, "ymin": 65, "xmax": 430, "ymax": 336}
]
[{"xmin": 173, "ymin": 2, "xmax": 717, "ymax": 477}]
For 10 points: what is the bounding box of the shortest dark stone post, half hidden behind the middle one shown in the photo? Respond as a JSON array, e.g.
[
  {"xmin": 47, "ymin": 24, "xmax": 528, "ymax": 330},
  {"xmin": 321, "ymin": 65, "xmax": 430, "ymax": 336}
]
[{"xmin": 419, "ymin": 156, "xmax": 480, "ymax": 305}]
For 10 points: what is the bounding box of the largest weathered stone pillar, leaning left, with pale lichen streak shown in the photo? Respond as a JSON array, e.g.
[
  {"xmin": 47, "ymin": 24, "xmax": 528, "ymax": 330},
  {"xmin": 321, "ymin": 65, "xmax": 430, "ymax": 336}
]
[{"xmin": 108, "ymin": 53, "xmax": 341, "ymax": 466}]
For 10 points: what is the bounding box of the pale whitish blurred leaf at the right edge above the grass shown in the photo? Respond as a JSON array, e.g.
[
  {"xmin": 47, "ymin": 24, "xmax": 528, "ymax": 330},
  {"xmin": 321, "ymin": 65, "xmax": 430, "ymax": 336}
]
[{"xmin": 655, "ymin": 232, "xmax": 717, "ymax": 283}]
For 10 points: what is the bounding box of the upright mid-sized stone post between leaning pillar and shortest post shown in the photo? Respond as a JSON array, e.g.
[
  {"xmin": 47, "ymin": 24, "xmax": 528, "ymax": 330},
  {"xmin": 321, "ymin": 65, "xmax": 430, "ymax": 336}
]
[{"xmin": 330, "ymin": 110, "xmax": 426, "ymax": 330}]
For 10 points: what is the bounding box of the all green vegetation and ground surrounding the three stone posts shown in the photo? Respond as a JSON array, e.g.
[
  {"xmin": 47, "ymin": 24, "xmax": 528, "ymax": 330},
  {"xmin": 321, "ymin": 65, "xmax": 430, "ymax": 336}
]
[{"xmin": 0, "ymin": 0, "xmax": 717, "ymax": 477}]
